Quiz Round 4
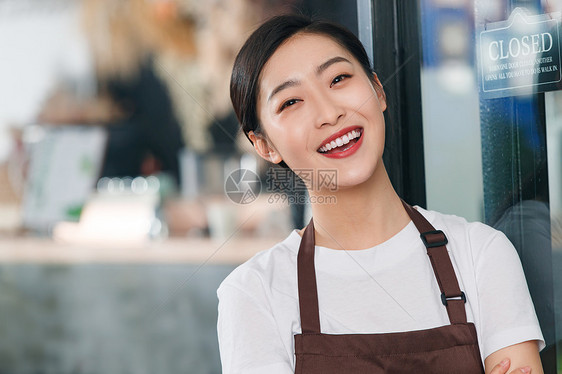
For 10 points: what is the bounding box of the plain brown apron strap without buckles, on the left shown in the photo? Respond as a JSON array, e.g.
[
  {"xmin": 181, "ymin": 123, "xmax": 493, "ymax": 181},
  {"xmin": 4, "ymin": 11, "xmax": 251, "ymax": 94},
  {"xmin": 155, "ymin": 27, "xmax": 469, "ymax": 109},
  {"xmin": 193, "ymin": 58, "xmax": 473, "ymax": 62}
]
[{"xmin": 297, "ymin": 218, "xmax": 320, "ymax": 334}]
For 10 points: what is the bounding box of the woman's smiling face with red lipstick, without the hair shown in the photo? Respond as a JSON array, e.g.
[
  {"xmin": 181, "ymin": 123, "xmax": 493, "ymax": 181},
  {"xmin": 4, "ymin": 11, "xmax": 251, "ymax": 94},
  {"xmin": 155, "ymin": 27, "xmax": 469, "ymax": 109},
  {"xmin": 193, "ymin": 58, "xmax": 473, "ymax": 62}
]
[{"xmin": 254, "ymin": 33, "xmax": 386, "ymax": 187}]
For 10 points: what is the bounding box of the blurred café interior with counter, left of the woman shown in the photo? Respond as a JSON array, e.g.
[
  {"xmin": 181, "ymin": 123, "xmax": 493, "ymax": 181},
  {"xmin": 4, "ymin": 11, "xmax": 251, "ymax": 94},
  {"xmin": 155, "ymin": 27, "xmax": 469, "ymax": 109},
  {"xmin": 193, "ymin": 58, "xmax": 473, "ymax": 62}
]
[{"xmin": 0, "ymin": 0, "xmax": 357, "ymax": 374}]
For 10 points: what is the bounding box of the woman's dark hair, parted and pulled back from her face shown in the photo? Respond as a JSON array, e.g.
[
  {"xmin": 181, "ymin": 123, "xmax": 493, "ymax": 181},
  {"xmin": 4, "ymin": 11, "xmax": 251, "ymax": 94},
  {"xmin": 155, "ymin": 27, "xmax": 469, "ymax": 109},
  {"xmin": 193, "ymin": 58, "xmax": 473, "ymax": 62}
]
[{"xmin": 230, "ymin": 15, "xmax": 373, "ymax": 166}]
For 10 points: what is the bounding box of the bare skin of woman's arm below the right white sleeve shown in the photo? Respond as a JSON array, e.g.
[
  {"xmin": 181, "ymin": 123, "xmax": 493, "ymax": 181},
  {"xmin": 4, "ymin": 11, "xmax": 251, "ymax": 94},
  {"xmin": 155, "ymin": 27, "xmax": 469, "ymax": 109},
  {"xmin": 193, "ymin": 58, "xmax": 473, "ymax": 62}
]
[{"xmin": 484, "ymin": 340, "xmax": 544, "ymax": 374}]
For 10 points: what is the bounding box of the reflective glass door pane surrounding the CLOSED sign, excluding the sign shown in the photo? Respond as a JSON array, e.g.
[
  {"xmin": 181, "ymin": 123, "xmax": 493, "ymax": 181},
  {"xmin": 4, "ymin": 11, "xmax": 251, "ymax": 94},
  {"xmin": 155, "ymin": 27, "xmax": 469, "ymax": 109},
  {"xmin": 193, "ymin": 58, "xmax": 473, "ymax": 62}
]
[{"xmin": 420, "ymin": 0, "xmax": 562, "ymax": 372}]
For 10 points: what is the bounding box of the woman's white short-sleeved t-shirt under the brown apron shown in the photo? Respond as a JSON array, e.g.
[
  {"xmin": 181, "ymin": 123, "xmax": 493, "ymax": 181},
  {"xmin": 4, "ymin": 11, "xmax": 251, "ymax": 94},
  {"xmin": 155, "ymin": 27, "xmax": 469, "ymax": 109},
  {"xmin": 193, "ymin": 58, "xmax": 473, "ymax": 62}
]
[{"xmin": 217, "ymin": 208, "xmax": 544, "ymax": 374}]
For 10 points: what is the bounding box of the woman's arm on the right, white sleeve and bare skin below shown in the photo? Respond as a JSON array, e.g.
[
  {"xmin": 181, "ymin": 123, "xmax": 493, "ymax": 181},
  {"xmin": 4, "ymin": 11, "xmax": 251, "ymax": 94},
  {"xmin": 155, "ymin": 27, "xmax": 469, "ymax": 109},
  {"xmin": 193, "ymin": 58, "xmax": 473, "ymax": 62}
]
[{"xmin": 473, "ymin": 226, "xmax": 544, "ymax": 374}]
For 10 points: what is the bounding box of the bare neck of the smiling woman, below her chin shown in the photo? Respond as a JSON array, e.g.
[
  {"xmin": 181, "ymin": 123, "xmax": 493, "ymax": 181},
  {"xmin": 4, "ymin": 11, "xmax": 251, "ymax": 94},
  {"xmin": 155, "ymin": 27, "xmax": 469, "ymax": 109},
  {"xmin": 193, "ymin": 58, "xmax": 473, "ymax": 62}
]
[{"xmin": 309, "ymin": 165, "xmax": 410, "ymax": 250}]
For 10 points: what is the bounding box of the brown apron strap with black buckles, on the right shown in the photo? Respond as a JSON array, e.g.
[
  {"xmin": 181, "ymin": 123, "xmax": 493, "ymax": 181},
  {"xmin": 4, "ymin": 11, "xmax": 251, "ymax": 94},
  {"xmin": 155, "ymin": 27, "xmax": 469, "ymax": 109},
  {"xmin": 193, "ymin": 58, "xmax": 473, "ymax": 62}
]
[{"xmin": 402, "ymin": 200, "xmax": 467, "ymax": 324}]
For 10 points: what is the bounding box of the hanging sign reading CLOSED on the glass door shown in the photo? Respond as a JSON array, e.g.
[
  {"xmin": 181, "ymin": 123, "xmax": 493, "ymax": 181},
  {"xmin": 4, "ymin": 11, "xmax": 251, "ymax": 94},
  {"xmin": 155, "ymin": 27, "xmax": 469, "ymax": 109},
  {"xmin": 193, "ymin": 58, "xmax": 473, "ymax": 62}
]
[{"xmin": 479, "ymin": 8, "xmax": 562, "ymax": 98}]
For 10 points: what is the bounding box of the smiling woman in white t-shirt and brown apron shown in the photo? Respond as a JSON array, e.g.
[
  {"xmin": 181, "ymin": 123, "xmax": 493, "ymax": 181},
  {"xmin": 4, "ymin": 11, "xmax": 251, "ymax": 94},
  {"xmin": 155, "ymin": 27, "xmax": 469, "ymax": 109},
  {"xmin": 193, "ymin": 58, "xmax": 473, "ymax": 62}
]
[{"xmin": 217, "ymin": 16, "xmax": 544, "ymax": 374}]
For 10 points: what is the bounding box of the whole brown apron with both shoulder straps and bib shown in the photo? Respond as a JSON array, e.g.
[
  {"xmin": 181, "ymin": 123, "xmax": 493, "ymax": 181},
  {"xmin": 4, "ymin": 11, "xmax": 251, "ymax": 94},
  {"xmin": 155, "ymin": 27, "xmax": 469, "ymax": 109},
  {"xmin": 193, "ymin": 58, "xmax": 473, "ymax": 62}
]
[{"xmin": 295, "ymin": 203, "xmax": 484, "ymax": 374}]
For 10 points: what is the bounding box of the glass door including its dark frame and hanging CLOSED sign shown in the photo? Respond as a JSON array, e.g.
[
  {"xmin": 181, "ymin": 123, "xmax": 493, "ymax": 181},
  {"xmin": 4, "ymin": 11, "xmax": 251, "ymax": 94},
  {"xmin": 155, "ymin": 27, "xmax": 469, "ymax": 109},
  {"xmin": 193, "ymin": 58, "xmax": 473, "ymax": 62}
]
[{"xmin": 357, "ymin": 0, "xmax": 562, "ymax": 373}]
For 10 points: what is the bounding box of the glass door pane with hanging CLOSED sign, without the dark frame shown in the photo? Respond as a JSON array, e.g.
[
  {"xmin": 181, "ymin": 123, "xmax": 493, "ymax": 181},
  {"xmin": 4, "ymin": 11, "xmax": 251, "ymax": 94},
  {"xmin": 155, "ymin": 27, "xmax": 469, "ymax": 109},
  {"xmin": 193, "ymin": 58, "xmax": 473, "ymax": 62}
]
[{"xmin": 419, "ymin": 0, "xmax": 562, "ymax": 373}]
